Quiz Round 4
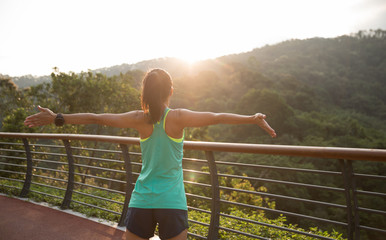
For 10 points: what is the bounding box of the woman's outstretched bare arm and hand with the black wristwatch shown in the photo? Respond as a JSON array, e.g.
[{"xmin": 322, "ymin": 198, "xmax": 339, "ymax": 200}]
[{"xmin": 24, "ymin": 106, "xmax": 143, "ymax": 129}]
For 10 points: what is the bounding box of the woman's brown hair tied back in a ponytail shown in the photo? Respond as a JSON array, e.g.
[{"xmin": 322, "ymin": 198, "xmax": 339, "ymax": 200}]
[{"xmin": 141, "ymin": 69, "xmax": 173, "ymax": 123}]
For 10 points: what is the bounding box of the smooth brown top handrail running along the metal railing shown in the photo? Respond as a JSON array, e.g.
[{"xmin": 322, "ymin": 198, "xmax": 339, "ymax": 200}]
[{"xmin": 0, "ymin": 132, "xmax": 386, "ymax": 162}]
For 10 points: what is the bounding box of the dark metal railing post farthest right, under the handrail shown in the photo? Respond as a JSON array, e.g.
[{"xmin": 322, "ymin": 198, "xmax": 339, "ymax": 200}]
[{"xmin": 339, "ymin": 159, "xmax": 354, "ymax": 240}]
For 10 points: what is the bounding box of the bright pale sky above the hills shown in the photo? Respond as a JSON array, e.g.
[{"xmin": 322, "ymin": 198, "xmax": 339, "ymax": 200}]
[{"xmin": 0, "ymin": 0, "xmax": 386, "ymax": 77}]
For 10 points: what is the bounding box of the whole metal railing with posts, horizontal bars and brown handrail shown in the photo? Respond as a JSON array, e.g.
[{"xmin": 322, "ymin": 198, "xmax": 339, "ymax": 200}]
[{"xmin": 0, "ymin": 133, "xmax": 386, "ymax": 239}]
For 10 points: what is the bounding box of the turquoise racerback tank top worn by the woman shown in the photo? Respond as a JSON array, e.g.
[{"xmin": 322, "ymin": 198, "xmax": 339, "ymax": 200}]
[{"xmin": 129, "ymin": 108, "xmax": 188, "ymax": 210}]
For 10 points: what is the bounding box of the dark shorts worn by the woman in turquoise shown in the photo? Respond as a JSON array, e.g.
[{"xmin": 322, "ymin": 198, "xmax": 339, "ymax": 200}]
[{"xmin": 125, "ymin": 208, "xmax": 189, "ymax": 239}]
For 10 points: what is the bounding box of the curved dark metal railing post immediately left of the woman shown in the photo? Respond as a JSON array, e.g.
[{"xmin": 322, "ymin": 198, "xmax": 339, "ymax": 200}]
[{"xmin": 118, "ymin": 144, "xmax": 133, "ymax": 227}]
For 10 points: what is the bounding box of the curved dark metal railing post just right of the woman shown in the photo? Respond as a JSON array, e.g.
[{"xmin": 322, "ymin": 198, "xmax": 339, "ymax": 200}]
[{"xmin": 205, "ymin": 151, "xmax": 220, "ymax": 240}]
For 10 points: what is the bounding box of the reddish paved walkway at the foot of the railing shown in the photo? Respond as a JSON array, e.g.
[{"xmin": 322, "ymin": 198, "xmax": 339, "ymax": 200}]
[{"xmin": 0, "ymin": 196, "xmax": 125, "ymax": 240}]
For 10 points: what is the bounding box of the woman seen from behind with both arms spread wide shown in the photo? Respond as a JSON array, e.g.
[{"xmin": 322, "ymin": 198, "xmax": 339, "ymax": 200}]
[{"xmin": 24, "ymin": 69, "xmax": 276, "ymax": 239}]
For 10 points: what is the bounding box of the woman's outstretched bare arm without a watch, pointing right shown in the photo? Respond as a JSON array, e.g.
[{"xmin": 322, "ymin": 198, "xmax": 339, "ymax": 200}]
[{"xmin": 178, "ymin": 109, "xmax": 276, "ymax": 137}]
